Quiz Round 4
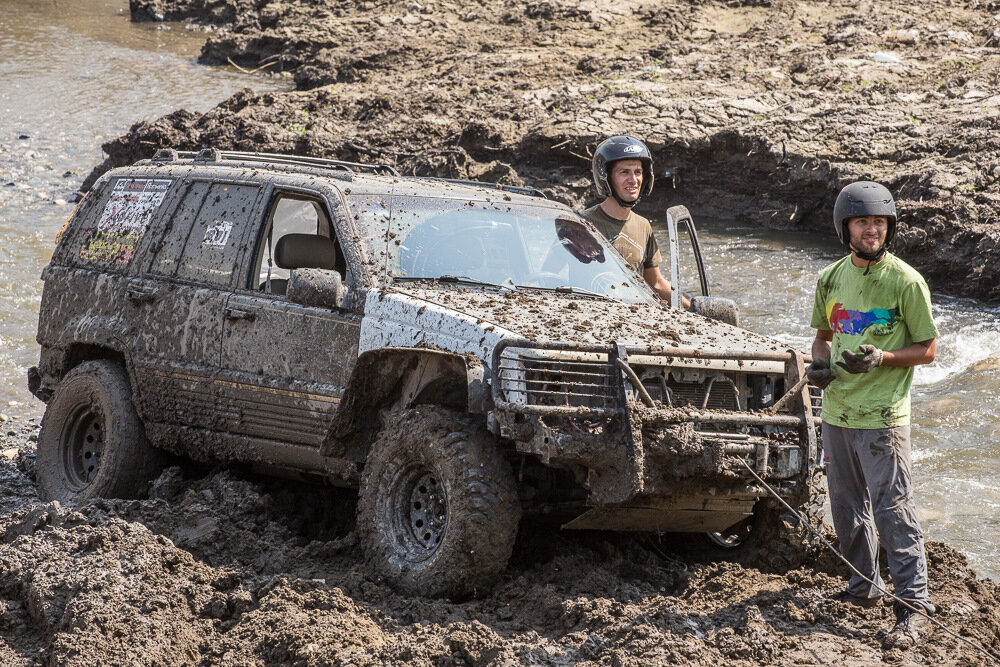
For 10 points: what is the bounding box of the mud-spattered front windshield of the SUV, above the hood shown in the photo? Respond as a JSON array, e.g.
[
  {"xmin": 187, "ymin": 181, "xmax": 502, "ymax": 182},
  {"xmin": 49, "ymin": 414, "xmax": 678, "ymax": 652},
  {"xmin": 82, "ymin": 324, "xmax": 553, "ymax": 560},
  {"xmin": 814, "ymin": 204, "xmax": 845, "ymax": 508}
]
[{"xmin": 352, "ymin": 196, "xmax": 652, "ymax": 302}]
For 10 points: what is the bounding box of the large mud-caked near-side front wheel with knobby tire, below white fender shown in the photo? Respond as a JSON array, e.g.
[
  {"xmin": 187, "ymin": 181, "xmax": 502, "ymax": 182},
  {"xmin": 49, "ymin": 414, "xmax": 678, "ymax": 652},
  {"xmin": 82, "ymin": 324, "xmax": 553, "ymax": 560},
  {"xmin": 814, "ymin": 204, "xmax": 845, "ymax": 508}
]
[{"xmin": 357, "ymin": 406, "xmax": 521, "ymax": 599}]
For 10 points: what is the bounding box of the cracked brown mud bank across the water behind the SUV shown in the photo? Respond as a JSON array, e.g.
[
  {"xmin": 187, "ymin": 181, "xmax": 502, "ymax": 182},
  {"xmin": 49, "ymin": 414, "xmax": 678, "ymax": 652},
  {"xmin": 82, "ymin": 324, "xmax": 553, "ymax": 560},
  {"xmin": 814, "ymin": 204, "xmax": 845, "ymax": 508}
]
[{"xmin": 88, "ymin": 0, "xmax": 1000, "ymax": 302}]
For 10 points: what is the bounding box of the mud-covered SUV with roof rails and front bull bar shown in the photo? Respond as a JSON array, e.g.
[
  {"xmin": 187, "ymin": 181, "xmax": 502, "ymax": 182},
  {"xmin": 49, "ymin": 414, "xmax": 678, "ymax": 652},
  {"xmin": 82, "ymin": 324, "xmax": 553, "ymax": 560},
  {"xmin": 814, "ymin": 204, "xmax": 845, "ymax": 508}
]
[{"xmin": 29, "ymin": 150, "xmax": 819, "ymax": 596}]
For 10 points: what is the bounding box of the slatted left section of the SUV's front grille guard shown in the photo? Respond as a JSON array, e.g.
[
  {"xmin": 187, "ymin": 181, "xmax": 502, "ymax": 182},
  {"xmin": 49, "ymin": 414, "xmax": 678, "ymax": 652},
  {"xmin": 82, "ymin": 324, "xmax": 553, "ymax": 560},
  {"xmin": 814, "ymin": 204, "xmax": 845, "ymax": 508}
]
[{"xmin": 498, "ymin": 349, "xmax": 617, "ymax": 409}]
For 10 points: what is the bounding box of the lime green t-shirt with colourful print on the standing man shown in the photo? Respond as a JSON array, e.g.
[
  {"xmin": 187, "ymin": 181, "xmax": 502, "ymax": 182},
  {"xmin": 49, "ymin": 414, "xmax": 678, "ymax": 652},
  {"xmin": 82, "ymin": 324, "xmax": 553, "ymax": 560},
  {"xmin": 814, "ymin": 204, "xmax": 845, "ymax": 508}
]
[{"xmin": 811, "ymin": 253, "xmax": 938, "ymax": 428}]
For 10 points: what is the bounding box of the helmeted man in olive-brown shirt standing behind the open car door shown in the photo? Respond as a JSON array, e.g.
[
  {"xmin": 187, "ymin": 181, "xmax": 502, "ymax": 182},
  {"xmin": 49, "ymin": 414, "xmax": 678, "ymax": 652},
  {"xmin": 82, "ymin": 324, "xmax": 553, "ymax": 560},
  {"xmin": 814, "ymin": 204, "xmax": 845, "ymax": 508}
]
[{"xmin": 583, "ymin": 136, "xmax": 688, "ymax": 307}]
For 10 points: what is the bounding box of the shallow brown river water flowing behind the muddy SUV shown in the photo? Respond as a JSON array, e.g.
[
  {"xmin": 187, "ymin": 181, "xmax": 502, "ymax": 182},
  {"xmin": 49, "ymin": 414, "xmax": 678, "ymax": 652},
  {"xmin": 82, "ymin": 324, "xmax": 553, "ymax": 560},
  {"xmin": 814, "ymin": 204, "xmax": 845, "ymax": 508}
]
[{"xmin": 0, "ymin": 0, "xmax": 1000, "ymax": 579}]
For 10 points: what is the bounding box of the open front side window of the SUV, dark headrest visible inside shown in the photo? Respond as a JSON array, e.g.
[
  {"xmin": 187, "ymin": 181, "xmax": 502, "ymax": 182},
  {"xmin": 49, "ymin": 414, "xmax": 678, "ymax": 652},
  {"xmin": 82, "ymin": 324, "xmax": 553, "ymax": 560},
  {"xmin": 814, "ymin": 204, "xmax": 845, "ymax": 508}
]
[{"xmin": 247, "ymin": 194, "xmax": 346, "ymax": 294}]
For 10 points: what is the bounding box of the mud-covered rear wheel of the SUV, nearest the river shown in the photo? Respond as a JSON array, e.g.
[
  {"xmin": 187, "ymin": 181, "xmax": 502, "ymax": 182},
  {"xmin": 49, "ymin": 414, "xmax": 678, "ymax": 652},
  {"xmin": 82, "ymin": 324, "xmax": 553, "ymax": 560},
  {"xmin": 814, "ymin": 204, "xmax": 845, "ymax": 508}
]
[{"xmin": 36, "ymin": 360, "xmax": 162, "ymax": 503}]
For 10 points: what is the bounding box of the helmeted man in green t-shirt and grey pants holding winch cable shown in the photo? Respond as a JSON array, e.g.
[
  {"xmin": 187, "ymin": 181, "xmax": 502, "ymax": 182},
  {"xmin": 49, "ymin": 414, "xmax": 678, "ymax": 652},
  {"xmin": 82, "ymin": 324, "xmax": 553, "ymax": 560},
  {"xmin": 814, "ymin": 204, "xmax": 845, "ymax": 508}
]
[{"xmin": 808, "ymin": 181, "xmax": 938, "ymax": 647}]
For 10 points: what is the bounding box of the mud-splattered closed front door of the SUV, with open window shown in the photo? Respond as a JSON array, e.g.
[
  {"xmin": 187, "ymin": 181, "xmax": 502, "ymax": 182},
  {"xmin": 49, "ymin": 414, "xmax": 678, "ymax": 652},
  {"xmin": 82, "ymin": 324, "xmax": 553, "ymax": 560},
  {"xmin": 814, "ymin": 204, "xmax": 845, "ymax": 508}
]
[{"xmin": 220, "ymin": 187, "xmax": 361, "ymax": 448}]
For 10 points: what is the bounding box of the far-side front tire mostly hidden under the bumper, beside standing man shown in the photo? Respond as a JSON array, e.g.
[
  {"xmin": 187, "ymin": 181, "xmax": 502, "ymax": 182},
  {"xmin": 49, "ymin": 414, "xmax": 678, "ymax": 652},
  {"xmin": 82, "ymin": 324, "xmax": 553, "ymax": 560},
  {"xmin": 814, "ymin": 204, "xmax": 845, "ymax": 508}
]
[{"xmin": 708, "ymin": 468, "xmax": 826, "ymax": 573}]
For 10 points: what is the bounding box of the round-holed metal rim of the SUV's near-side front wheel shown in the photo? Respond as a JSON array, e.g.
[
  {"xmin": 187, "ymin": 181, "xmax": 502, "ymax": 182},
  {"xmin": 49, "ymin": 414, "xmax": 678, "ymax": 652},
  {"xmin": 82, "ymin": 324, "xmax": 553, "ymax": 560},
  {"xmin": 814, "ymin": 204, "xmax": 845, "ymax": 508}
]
[{"xmin": 390, "ymin": 465, "xmax": 448, "ymax": 561}]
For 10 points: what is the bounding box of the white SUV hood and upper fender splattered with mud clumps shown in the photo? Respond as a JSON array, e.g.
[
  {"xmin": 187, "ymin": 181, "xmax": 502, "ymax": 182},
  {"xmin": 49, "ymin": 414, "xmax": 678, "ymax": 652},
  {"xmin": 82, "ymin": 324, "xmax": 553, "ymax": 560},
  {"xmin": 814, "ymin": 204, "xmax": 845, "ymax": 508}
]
[{"xmin": 361, "ymin": 285, "xmax": 785, "ymax": 359}]
